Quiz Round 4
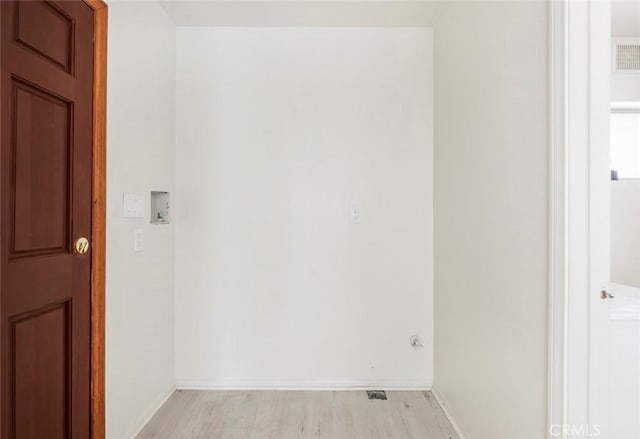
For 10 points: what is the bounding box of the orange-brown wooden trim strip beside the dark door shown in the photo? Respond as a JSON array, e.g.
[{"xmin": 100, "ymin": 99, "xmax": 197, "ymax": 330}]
[{"xmin": 84, "ymin": 0, "xmax": 108, "ymax": 439}]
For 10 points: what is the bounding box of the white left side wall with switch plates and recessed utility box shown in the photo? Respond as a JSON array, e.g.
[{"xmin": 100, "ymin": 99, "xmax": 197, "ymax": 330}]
[{"xmin": 106, "ymin": 2, "xmax": 175, "ymax": 439}]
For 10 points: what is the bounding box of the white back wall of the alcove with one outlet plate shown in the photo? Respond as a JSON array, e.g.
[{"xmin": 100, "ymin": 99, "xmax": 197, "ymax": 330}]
[{"xmin": 175, "ymin": 28, "xmax": 433, "ymax": 387}]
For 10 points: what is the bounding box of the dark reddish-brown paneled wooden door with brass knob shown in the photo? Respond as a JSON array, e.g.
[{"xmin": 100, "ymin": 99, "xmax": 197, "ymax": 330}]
[{"xmin": 0, "ymin": 1, "xmax": 93, "ymax": 439}]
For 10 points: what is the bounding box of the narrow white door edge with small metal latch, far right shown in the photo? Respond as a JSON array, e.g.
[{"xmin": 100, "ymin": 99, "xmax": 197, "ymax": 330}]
[{"xmin": 589, "ymin": 1, "xmax": 612, "ymax": 439}]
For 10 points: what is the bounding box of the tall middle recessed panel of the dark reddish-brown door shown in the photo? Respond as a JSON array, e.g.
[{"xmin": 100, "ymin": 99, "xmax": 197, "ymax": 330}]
[{"xmin": 10, "ymin": 78, "xmax": 73, "ymax": 258}]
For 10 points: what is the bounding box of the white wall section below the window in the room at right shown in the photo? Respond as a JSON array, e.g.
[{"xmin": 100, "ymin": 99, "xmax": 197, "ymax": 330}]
[{"xmin": 611, "ymin": 180, "xmax": 640, "ymax": 288}]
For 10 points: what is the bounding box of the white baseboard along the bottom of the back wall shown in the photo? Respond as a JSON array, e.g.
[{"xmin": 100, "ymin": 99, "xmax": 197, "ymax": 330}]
[{"xmin": 176, "ymin": 380, "xmax": 431, "ymax": 391}]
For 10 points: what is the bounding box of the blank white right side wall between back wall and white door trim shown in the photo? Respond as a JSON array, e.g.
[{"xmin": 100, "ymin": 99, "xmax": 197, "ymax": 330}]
[{"xmin": 434, "ymin": 2, "xmax": 549, "ymax": 439}]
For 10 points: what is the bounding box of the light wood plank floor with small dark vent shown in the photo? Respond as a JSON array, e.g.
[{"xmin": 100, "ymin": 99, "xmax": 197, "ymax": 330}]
[{"xmin": 137, "ymin": 390, "xmax": 459, "ymax": 439}]
